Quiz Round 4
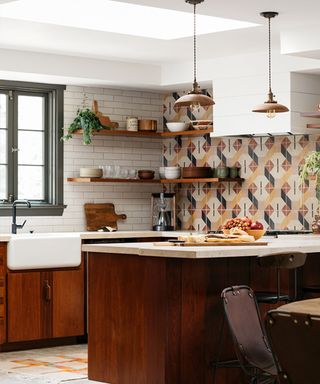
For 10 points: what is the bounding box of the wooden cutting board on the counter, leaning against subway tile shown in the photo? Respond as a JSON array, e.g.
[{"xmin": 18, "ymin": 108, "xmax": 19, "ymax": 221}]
[{"xmin": 84, "ymin": 203, "xmax": 127, "ymax": 231}]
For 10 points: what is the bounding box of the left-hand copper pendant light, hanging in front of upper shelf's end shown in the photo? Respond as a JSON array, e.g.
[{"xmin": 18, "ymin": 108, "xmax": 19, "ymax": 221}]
[{"xmin": 174, "ymin": 0, "xmax": 214, "ymax": 112}]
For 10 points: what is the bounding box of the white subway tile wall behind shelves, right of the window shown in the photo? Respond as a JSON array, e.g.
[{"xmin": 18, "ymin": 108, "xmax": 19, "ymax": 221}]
[{"xmin": 0, "ymin": 86, "xmax": 163, "ymax": 233}]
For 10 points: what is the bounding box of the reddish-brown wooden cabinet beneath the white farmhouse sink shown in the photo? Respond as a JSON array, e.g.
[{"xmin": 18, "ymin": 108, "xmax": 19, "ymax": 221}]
[{"xmin": 0, "ymin": 243, "xmax": 86, "ymax": 345}]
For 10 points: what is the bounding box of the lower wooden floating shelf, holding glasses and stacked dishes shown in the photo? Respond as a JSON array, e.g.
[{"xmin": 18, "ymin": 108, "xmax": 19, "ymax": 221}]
[{"xmin": 67, "ymin": 177, "xmax": 244, "ymax": 184}]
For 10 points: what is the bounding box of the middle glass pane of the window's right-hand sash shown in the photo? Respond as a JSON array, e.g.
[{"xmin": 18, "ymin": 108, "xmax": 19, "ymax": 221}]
[{"xmin": 18, "ymin": 131, "xmax": 44, "ymax": 165}]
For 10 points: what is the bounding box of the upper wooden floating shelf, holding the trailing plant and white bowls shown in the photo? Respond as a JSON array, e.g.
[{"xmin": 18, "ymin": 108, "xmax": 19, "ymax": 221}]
[{"xmin": 75, "ymin": 129, "xmax": 213, "ymax": 138}]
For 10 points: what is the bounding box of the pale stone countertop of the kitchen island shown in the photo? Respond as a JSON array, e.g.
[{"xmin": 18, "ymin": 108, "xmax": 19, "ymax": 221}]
[{"xmin": 82, "ymin": 235, "xmax": 320, "ymax": 259}]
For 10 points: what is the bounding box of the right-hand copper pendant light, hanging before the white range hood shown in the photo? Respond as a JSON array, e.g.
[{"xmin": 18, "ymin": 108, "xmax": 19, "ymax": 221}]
[{"xmin": 252, "ymin": 12, "xmax": 289, "ymax": 118}]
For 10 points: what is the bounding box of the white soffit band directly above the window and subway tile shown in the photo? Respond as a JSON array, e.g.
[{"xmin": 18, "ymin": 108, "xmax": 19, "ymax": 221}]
[{"xmin": 0, "ymin": 48, "xmax": 161, "ymax": 88}]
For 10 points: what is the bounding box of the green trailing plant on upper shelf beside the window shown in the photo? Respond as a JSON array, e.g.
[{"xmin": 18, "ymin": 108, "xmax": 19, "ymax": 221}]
[{"xmin": 62, "ymin": 108, "xmax": 111, "ymax": 145}]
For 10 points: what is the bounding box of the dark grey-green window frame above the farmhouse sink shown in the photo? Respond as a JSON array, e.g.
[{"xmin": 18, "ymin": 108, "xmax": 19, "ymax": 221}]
[{"xmin": 0, "ymin": 80, "xmax": 66, "ymax": 216}]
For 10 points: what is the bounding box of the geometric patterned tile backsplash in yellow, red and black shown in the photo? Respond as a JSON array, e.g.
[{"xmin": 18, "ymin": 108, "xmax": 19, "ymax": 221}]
[{"xmin": 162, "ymin": 94, "xmax": 320, "ymax": 231}]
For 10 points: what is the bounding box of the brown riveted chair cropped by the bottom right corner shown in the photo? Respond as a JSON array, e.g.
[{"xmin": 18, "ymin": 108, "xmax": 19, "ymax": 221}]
[{"xmin": 265, "ymin": 298, "xmax": 320, "ymax": 384}]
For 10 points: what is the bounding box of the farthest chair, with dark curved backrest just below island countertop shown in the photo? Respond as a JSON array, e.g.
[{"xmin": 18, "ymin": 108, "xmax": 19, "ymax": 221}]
[{"xmin": 255, "ymin": 252, "xmax": 307, "ymax": 304}]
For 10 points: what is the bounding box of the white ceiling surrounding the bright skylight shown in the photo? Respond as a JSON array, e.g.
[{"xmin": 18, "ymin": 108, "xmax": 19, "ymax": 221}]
[{"xmin": 0, "ymin": 0, "xmax": 320, "ymax": 83}]
